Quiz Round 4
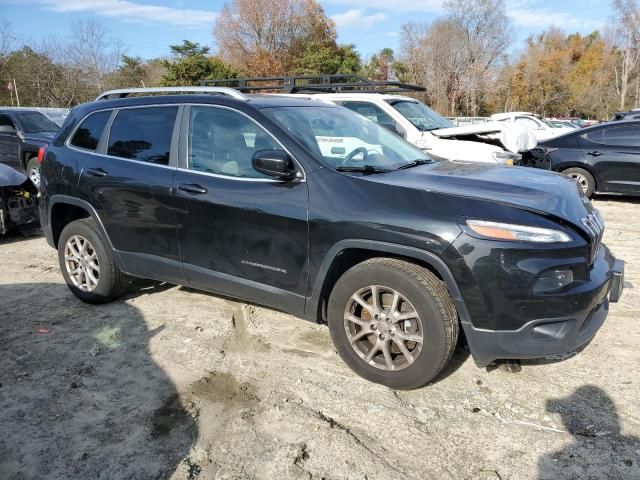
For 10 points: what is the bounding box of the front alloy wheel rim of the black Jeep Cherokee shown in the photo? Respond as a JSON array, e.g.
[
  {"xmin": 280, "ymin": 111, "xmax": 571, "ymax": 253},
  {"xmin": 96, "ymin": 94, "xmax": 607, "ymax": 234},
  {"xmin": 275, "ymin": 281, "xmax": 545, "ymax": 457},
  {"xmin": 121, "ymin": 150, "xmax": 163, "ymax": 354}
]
[{"xmin": 344, "ymin": 285, "xmax": 424, "ymax": 371}]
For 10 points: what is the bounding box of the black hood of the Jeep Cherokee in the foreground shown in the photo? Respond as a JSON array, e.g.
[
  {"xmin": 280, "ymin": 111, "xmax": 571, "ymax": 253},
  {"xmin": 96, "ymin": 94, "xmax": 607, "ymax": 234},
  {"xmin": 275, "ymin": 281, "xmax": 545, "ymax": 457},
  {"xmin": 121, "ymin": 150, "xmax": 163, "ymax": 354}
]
[{"xmin": 368, "ymin": 161, "xmax": 593, "ymax": 229}]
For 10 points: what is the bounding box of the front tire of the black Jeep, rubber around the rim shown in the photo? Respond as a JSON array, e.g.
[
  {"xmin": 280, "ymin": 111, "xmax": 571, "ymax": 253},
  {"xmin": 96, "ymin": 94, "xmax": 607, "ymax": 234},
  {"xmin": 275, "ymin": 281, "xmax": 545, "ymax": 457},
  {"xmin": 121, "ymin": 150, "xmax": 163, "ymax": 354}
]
[{"xmin": 328, "ymin": 258, "xmax": 459, "ymax": 389}]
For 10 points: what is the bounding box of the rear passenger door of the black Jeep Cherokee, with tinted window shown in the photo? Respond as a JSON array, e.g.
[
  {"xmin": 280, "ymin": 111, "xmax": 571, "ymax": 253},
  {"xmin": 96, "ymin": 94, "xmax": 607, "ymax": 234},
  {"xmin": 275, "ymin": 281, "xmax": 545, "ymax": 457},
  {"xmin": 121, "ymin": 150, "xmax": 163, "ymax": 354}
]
[{"xmin": 76, "ymin": 105, "xmax": 184, "ymax": 283}]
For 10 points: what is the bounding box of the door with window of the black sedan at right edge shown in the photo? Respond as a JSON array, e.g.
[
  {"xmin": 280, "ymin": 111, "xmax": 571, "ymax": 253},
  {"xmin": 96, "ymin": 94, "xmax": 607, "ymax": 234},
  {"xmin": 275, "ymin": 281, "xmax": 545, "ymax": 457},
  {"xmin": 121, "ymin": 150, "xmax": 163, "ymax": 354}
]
[{"xmin": 580, "ymin": 123, "xmax": 640, "ymax": 194}]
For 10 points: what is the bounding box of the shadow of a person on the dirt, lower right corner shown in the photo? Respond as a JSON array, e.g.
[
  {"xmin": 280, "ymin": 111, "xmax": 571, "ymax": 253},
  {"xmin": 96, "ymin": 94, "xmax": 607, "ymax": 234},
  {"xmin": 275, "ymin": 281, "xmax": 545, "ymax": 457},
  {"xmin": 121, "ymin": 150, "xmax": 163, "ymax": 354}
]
[{"xmin": 538, "ymin": 385, "xmax": 640, "ymax": 480}]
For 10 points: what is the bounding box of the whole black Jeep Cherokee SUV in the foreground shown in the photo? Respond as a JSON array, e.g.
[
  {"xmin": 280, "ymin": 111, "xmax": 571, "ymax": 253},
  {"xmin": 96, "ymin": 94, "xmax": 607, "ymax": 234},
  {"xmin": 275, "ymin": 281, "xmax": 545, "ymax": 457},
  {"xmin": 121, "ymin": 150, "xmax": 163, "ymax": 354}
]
[{"xmin": 40, "ymin": 87, "xmax": 623, "ymax": 388}]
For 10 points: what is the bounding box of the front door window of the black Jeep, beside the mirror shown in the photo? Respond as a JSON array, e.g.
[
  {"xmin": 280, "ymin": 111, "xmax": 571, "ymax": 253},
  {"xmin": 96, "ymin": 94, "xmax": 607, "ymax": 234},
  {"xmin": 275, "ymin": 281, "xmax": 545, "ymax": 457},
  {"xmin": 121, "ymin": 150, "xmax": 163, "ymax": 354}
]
[{"xmin": 188, "ymin": 107, "xmax": 282, "ymax": 178}]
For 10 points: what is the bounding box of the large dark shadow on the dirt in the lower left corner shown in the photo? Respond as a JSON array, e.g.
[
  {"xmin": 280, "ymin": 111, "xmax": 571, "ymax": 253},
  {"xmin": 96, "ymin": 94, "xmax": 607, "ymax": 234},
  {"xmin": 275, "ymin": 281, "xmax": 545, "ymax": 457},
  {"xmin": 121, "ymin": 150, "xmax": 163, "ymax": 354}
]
[{"xmin": 0, "ymin": 283, "xmax": 198, "ymax": 479}]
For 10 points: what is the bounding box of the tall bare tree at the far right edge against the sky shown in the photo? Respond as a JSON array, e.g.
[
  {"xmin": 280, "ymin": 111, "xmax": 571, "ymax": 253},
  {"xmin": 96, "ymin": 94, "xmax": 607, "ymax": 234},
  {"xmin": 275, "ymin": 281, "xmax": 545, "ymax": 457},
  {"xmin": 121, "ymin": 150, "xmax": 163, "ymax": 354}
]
[{"xmin": 613, "ymin": 0, "xmax": 640, "ymax": 110}]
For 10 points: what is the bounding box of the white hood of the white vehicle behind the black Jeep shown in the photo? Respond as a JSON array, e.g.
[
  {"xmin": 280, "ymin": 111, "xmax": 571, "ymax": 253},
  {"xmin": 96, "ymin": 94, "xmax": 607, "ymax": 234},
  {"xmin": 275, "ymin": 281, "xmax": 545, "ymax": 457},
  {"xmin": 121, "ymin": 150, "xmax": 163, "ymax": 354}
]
[{"xmin": 431, "ymin": 122, "xmax": 537, "ymax": 153}]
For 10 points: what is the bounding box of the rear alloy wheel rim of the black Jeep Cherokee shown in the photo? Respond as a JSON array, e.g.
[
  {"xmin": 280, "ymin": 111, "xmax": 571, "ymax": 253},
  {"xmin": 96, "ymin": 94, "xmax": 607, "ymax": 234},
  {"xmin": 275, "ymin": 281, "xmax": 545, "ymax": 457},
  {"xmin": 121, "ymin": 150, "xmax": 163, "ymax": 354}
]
[{"xmin": 64, "ymin": 235, "xmax": 100, "ymax": 292}]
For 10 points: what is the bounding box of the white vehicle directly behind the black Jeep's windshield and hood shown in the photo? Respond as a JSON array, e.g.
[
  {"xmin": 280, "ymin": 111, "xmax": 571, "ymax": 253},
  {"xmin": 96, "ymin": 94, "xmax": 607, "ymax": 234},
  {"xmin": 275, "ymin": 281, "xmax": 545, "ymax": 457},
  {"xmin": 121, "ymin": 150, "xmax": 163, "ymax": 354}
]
[{"xmin": 291, "ymin": 92, "xmax": 537, "ymax": 164}]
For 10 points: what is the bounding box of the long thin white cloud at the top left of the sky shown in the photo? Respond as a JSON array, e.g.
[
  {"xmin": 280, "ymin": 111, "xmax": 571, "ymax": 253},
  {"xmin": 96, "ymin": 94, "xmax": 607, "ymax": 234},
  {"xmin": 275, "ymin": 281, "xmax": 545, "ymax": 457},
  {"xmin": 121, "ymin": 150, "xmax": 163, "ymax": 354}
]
[{"xmin": 38, "ymin": 0, "xmax": 217, "ymax": 27}]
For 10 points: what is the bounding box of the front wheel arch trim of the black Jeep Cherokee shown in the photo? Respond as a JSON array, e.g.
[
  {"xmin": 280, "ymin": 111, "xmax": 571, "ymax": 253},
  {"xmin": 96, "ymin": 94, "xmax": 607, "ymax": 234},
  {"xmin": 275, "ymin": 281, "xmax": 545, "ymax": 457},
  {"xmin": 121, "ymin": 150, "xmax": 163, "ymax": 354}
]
[{"xmin": 305, "ymin": 239, "xmax": 470, "ymax": 323}]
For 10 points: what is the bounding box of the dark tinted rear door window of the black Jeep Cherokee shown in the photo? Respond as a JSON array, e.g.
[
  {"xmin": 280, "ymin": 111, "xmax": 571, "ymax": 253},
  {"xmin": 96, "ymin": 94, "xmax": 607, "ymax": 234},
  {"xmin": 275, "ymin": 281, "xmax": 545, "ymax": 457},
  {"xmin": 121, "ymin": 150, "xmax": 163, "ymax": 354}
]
[{"xmin": 107, "ymin": 107, "xmax": 178, "ymax": 165}]
